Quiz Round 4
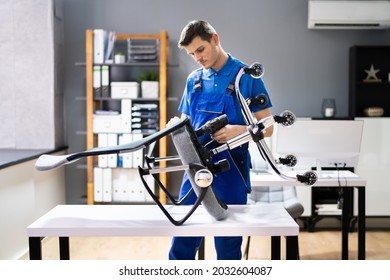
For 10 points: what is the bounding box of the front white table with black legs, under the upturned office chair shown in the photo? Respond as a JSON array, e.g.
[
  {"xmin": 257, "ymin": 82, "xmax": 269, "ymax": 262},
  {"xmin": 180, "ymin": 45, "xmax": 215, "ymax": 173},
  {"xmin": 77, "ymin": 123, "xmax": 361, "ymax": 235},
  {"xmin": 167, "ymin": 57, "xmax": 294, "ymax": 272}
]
[{"xmin": 27, "ymin": 205, "xmax": 299, "ymax": 259}]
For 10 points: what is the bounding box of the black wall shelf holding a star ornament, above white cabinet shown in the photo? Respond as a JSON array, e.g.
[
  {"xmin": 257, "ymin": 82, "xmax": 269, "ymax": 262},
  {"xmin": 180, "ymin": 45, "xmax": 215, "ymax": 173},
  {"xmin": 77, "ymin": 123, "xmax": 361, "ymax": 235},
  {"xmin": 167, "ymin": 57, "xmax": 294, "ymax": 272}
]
[{"xmin": 349, "ymin": 46, "xmax": 390, "ymax": 117}]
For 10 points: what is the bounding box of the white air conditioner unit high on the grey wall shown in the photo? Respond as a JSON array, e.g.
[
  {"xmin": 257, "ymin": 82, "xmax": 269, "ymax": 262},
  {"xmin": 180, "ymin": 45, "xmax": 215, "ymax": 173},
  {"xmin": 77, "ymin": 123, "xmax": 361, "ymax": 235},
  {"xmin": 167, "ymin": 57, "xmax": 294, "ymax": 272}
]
[{"xmin": 308, "ymin": 0, "xmax": 390, "ymax": 29}]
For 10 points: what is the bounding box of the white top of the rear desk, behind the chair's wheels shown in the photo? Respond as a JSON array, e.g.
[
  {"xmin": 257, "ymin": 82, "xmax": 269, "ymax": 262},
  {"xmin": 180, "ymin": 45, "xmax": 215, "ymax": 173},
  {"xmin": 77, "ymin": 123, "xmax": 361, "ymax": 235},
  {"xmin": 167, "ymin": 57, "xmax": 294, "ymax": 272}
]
[{"xmin": 250, "ymin": 170, "xmax": 366, "ymax": 187}]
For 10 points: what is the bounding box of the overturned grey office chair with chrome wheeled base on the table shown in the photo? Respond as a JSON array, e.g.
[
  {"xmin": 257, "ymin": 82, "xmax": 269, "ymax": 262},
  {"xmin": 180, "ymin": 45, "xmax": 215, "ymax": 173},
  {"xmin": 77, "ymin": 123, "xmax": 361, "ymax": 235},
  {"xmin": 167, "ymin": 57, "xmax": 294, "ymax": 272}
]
[{"xmin": 35, "ymin": 63, "xmax": 317, "ymax": 228}]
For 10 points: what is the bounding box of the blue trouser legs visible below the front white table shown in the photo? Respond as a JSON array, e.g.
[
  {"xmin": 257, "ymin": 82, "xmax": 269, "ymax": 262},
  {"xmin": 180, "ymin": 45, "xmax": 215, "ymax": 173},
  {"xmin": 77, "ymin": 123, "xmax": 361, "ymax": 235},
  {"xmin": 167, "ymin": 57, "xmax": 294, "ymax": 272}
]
[{"xmin": 169, "ymin": 236, "xmax": 242, "ymax": 260}]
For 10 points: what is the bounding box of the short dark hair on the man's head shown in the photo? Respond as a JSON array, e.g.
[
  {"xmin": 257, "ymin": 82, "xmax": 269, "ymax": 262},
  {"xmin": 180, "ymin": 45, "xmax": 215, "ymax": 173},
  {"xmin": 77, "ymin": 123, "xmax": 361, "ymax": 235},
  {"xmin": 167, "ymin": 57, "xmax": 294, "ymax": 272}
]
[{"xmin": 178, "ymin": 20, "xmax": 217, "ymax": 48}]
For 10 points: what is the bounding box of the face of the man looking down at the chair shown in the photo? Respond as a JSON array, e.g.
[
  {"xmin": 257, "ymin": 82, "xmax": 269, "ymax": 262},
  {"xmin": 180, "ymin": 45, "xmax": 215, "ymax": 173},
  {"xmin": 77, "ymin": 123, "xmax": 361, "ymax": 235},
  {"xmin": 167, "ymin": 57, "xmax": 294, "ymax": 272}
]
[{"xmin": 184, "ymin": 34, "xmax": 219, "ymax": 69}]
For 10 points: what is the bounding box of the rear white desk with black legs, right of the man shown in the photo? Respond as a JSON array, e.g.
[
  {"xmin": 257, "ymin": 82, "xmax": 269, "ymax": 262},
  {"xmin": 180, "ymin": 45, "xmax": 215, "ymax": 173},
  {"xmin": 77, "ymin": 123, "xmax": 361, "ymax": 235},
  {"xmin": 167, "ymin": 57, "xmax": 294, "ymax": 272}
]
[{"xmin": 251, "ymin": 171, "xmax": 366, "ymax": 260}]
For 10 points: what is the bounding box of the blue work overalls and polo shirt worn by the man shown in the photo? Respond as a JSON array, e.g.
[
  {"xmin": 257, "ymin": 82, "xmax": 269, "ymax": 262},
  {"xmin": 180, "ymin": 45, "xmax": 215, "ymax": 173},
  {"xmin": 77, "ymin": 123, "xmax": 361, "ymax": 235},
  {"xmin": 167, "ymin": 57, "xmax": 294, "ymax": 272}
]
[{"xmin": 169, "ymin": 54, "xmax": 272, "ymax": 260}]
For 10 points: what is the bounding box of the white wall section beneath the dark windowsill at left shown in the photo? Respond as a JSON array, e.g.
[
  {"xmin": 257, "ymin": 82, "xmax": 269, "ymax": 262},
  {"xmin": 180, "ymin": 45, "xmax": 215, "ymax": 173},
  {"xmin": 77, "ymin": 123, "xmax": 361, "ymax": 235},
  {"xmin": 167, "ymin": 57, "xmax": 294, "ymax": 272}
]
[{"xmin": 0, "ymin": 154, "xmax": 65, "ymax": 260}]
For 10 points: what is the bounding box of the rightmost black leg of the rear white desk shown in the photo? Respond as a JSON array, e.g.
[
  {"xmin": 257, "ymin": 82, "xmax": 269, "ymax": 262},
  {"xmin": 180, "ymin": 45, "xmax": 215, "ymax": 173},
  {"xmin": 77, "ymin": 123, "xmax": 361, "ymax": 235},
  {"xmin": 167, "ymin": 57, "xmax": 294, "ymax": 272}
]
[{"xmin": 358, "ymin": 187, "xmax": 366, "ymax": 260}]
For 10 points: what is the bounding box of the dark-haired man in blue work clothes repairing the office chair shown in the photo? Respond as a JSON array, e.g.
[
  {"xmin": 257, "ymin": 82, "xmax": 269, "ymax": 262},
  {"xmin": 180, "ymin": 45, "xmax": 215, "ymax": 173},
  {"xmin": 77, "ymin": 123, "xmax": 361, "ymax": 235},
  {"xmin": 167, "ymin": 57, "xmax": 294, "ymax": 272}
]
[{"xmin": 169, "ymin": 20, "xmax": 272, "ymax": 260}]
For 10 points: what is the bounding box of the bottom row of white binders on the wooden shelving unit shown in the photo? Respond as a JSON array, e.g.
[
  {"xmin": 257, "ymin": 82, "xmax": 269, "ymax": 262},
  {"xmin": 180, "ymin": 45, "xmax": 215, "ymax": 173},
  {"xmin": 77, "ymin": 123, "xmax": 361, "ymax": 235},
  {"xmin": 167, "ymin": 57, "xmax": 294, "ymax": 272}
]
[{"xmin": 94, "ymin": 167, "xmax": 154, "ymax": 202}]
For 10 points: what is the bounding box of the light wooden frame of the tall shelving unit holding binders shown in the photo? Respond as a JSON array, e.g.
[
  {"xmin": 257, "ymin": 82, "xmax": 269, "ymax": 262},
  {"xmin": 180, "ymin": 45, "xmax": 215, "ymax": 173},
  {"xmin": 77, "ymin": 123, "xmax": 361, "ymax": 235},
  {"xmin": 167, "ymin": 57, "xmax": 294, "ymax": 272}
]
[{"xmin": 85, "ymin": 29, "xmax": 169, "ymax": 204}]
